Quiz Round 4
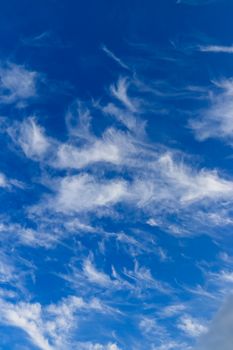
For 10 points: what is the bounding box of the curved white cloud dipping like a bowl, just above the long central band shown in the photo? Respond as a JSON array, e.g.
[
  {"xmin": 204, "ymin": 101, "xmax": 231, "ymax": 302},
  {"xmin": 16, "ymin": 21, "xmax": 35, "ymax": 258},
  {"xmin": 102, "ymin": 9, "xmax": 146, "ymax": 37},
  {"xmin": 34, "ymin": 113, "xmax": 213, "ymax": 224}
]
[{"xmin": 7, "ymin": 117, "xmax": 136, "ymax": 169}]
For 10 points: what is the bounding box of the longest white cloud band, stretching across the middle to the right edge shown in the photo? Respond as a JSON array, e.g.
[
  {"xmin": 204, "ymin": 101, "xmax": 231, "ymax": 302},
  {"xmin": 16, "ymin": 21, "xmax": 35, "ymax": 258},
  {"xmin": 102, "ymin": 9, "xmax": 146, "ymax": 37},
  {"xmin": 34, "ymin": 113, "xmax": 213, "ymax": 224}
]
[{"xmin": 32, "ymin": 148, "xmax": 233, "ymax": 234}]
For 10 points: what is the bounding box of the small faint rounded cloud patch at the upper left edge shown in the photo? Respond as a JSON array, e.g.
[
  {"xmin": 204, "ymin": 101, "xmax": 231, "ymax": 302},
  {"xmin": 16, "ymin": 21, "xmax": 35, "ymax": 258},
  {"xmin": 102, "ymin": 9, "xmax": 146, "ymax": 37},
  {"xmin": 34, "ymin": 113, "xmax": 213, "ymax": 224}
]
[{"xmin": 0, "ymin": 63, "xmax": 38, "ymax": 106}]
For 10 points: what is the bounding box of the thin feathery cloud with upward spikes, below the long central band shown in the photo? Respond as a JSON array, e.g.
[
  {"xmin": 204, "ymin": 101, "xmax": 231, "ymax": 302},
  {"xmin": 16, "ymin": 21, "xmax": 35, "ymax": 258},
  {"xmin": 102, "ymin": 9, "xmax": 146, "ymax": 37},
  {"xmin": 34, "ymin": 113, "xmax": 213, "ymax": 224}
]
[{"xmin": 58, "ymin": 256, "xmax": 173, "ymax": 300}]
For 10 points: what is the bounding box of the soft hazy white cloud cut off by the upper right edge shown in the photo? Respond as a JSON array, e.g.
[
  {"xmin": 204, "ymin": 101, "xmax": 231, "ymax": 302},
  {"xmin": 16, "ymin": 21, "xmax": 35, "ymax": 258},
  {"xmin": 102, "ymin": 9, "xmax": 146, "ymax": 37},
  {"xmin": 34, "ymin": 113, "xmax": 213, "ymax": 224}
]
[{"xmin": 189, "ymin": 79, "xmax": 233, "ymax": 145}]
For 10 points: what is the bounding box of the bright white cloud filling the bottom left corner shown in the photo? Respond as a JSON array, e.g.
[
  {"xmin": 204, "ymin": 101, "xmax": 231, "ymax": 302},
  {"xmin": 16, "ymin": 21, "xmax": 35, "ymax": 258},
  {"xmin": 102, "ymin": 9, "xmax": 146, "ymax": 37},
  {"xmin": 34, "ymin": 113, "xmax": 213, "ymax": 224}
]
[{"xmin": 0, "ymin": 296, "xmax": 111, "ymax": 350}]
